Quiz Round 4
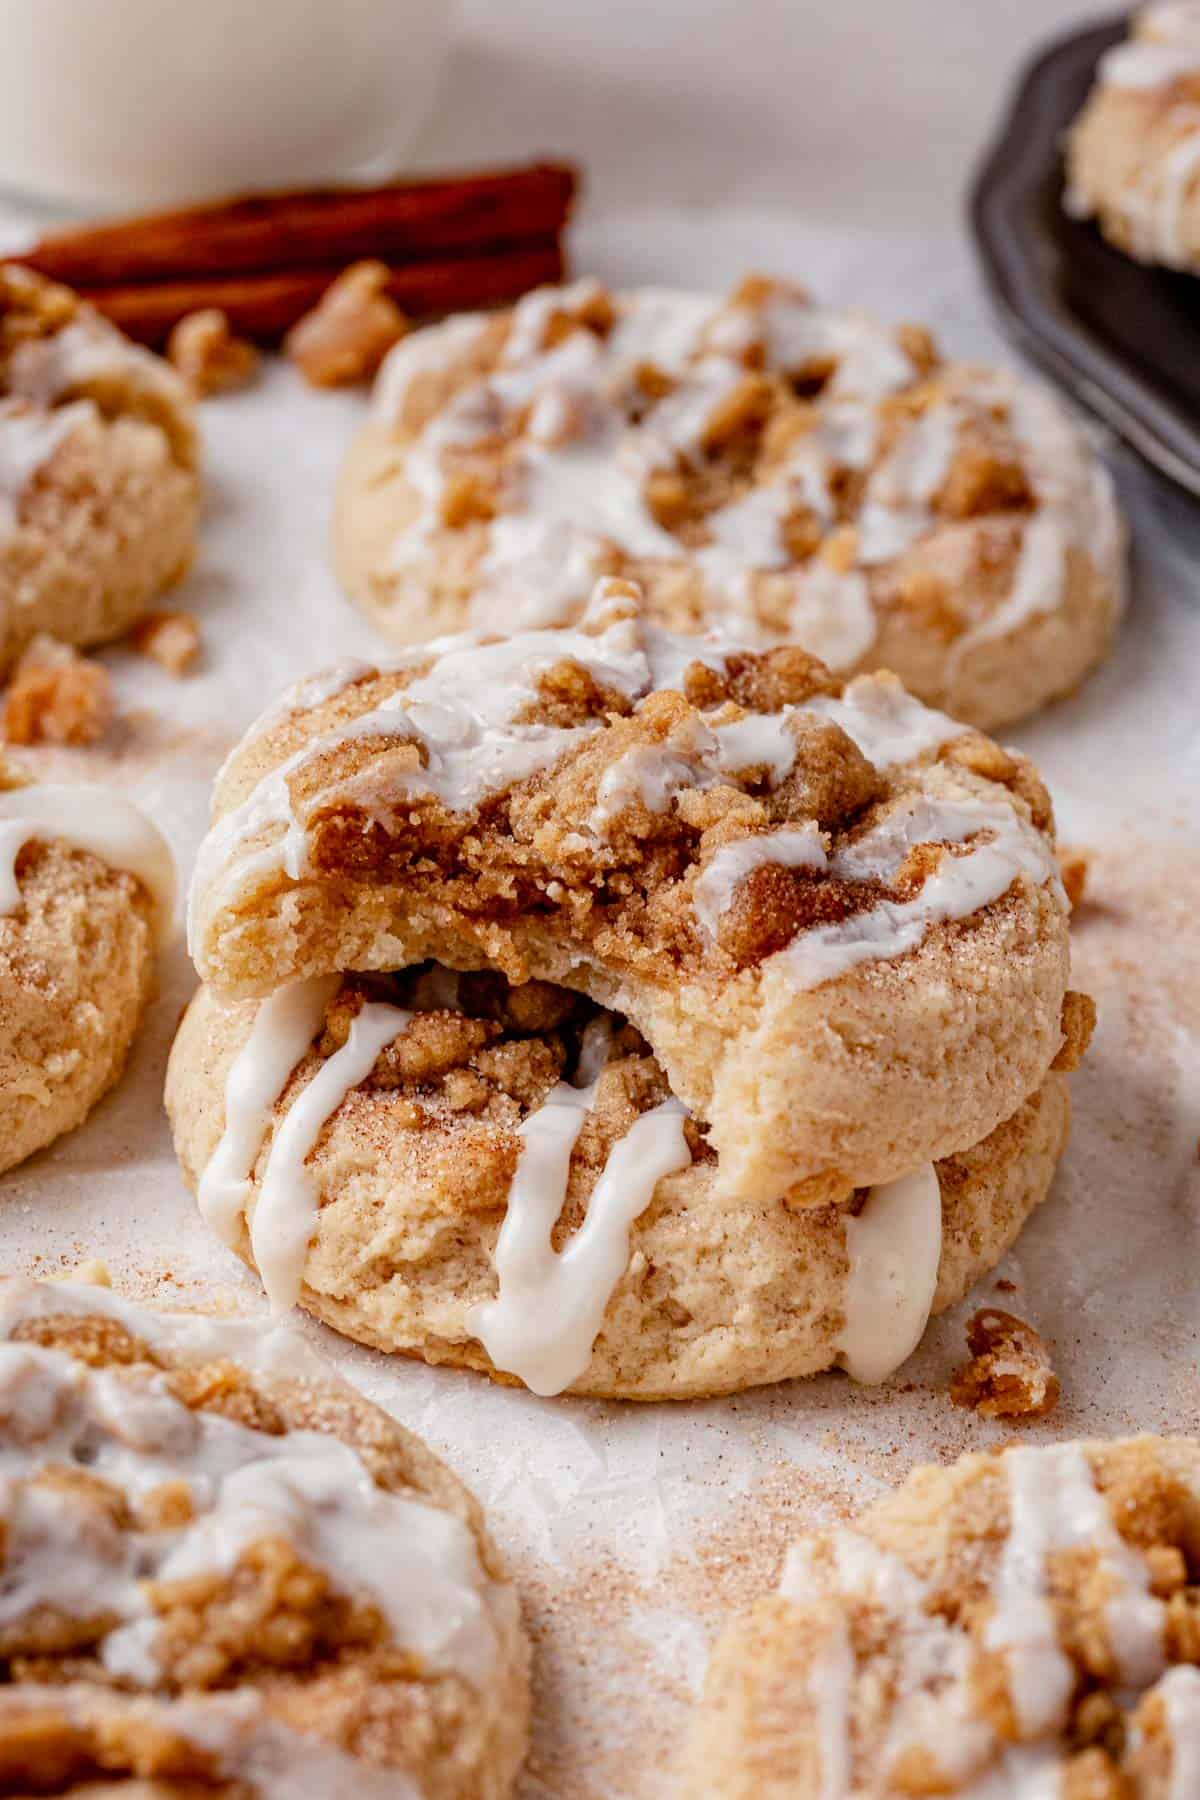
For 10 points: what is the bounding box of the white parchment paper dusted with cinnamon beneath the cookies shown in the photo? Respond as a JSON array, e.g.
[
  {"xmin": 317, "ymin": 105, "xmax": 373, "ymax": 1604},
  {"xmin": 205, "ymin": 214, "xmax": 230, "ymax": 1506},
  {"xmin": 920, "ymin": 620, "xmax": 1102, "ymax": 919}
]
[{"xmin": 0, "ymin": 211, "xmax": 1200, "ymax": 1800}]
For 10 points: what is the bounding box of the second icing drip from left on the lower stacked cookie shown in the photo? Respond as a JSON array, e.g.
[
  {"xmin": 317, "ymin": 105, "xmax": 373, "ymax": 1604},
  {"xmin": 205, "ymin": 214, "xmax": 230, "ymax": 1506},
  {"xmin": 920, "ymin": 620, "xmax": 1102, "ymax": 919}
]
[{"xmin": 248, "ymin": 1004, "xmax": 412, "ymax": 1312}]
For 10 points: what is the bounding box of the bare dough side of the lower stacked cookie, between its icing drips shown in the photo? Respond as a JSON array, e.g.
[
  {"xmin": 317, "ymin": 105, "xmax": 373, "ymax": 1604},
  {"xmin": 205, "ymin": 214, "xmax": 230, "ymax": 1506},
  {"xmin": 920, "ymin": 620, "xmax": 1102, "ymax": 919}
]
[{"xmin": 167, "ymin": 988, "xmax": 1069, "ymax": 1400}]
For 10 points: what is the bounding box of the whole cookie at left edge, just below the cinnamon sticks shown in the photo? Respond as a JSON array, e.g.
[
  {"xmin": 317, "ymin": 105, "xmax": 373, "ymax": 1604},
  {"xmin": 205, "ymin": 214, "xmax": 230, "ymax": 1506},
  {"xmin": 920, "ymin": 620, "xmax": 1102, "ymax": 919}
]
[{"xmin": 0, "ymin": 265, "xmax": 200, "ymax": 673}]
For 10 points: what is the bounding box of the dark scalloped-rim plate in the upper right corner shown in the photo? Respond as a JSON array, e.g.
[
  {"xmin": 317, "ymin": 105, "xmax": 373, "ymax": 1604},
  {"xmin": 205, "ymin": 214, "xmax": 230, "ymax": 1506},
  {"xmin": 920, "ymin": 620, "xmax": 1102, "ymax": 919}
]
[{"xmin": 970, "ymin": 18, "xmax": 1200, "ymax": 497}]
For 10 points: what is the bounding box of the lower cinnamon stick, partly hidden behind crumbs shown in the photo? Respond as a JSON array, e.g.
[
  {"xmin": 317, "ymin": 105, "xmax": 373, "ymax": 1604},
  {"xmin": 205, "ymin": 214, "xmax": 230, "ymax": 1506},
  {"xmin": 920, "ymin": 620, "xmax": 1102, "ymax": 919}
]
[{"xmin": 79, "ymin": 238, "xmax": 563, "ymax": 347}]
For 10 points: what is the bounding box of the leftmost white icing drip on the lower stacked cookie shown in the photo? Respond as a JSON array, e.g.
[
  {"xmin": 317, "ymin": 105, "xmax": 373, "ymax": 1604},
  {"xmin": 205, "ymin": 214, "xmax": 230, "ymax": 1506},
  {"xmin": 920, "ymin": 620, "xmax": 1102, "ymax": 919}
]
[{"xmin": 196, "ymin": 976, "xmax": 340, "ymax": 1246}]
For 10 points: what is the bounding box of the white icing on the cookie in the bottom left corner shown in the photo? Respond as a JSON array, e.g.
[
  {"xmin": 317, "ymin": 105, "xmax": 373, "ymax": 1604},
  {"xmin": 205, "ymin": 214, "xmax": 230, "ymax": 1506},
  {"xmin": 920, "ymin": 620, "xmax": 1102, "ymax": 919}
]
[{"xmin": 0, "ymin": 1289, "xmax": 513, "ymax": 1685}]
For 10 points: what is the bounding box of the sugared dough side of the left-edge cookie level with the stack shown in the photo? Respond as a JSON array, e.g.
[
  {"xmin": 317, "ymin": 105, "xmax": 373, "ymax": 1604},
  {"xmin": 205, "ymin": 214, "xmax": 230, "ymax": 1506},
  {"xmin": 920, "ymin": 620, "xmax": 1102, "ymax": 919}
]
[{"xmin": 0, "ymin": 844, "xmax": 155, "ymax": 1168}]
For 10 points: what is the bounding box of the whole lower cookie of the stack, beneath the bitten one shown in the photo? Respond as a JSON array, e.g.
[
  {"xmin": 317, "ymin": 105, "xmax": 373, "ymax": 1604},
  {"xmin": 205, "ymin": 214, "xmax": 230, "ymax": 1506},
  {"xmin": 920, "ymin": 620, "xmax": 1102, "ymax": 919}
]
[{"xmin": 167, "ymin": 965, "xmax": 1069, "ymax": 1400}]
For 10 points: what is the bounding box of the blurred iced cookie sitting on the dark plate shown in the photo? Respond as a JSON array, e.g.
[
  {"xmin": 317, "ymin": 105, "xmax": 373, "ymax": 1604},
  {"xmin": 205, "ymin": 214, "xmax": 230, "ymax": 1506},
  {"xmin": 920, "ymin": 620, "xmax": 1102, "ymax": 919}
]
[{"xmin": 1065, "ymin": 4, "xmax": 1200, "ymax": 274}]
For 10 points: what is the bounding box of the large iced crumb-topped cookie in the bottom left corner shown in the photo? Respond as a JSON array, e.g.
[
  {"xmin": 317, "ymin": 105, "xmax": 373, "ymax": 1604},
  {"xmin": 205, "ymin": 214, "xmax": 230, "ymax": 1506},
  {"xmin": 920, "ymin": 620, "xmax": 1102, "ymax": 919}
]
[{"xmin": 0, "ymin": 1282, "xmax": 529, "ymax": 1800}]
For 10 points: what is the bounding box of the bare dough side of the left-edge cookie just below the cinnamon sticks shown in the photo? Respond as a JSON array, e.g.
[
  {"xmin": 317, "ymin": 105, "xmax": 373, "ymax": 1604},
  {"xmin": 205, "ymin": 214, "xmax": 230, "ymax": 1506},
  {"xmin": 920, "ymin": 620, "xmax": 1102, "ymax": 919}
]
[{"xmin": 0, "ymin": 418, "xmax": 200, "ymax": 673}]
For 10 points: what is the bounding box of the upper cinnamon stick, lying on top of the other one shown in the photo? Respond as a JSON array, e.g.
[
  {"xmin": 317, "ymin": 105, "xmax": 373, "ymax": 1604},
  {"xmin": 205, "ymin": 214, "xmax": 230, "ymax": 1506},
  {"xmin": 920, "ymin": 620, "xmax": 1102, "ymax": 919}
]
[{"xmin": 22, "ymin": 162, "xmax": 576, "ymax": 288}]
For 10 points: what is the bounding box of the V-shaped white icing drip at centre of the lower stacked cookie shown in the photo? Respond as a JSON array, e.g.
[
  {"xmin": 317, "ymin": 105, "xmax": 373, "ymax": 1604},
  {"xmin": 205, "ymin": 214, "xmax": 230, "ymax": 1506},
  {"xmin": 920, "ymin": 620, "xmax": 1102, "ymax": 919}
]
[{"xmin": 471, "ymin": 1082, "xmax": 691, "ymax": 1395}]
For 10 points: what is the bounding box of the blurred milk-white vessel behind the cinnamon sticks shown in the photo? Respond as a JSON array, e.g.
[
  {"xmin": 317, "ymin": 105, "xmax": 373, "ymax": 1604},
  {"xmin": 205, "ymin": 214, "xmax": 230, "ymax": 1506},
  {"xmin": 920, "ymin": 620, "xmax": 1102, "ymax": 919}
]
[{"xmin": 0, "ymin": 0, "xmax": 453, "ymax": 207}]
